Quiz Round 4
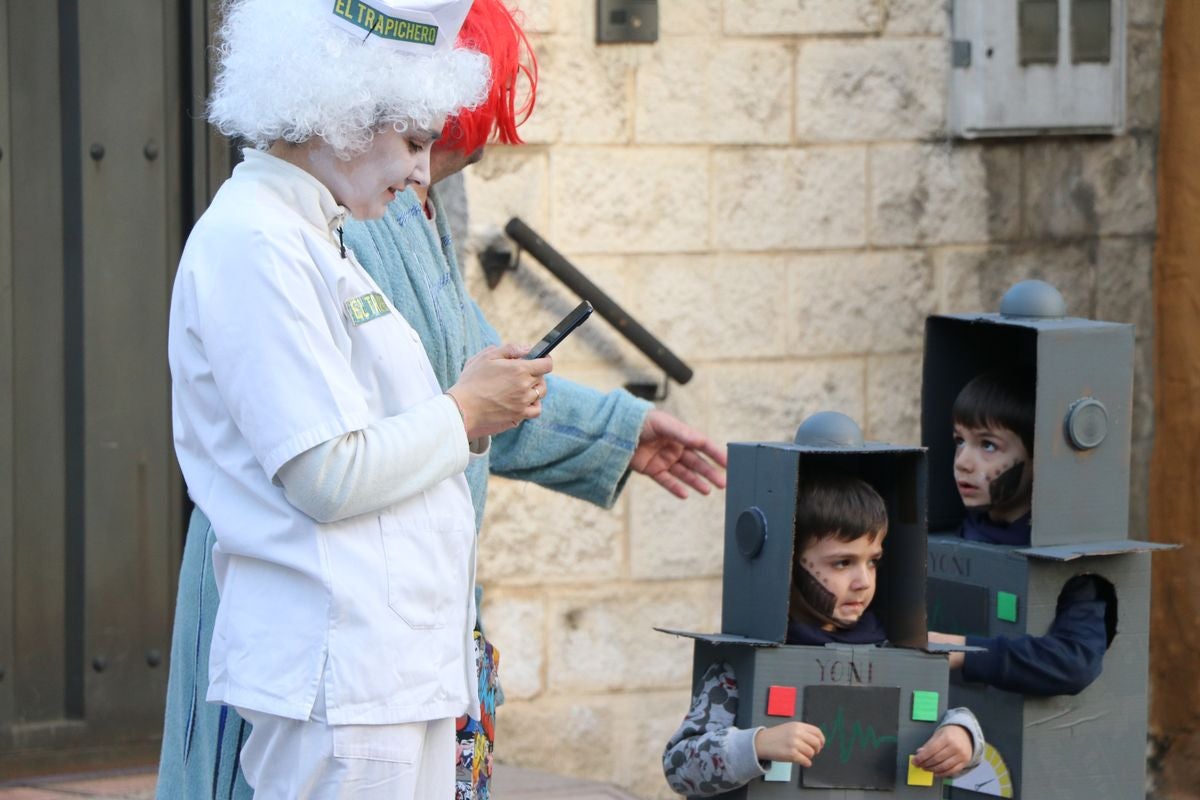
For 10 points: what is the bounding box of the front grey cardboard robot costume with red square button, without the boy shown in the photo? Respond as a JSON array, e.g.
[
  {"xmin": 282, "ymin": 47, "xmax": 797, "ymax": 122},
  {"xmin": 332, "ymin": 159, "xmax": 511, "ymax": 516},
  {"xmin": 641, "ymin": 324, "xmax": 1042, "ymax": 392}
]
[{"xmin": 660, "ymin": 413, "xmax": 979, "ymax": 800}]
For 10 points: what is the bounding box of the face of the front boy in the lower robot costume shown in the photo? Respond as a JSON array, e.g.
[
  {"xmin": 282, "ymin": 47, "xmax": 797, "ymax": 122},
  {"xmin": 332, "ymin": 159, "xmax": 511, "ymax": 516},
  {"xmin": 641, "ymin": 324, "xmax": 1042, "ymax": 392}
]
[{"xmin": 800, "ymin": 533, "xmax": 883, "ymax": 628}]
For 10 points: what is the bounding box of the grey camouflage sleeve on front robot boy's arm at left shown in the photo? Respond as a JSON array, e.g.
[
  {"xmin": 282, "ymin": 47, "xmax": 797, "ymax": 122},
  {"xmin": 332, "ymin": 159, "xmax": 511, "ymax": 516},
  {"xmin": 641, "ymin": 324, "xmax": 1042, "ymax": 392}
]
[{"xmin": 662, "ymin": 663, "xmax": 767, "ymax": 798}]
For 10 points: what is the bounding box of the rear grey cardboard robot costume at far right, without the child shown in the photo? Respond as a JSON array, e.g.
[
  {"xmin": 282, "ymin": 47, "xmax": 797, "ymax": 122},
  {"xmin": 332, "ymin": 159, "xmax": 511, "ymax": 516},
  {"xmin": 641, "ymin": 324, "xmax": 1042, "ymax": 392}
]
[{"xmin": 922, "ymin": 281, "xmax": 1170, "ymax": 800}]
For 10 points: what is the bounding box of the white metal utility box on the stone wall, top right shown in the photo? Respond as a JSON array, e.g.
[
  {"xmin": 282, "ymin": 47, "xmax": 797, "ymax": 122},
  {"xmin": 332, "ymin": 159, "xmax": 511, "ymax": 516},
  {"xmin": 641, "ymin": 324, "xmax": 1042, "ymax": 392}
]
[{"xmin": 948, "ymin": 0, "xmax": 1126, "ymax": 138}]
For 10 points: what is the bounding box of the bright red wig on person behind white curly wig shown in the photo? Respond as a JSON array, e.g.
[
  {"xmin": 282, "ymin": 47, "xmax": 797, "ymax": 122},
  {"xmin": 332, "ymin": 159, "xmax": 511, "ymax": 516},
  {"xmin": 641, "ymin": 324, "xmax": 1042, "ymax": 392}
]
[{"xmin": 443, "ymin": 0, "xmax": 538, "ymax": 154}]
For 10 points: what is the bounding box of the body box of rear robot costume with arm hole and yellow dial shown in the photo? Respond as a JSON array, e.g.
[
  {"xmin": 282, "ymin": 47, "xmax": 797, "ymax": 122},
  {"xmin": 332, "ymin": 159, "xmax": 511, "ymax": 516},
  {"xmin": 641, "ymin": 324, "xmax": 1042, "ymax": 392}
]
[{"xmin": 929, "ymin": 536, "xmax": 1172, "ymax": 800}]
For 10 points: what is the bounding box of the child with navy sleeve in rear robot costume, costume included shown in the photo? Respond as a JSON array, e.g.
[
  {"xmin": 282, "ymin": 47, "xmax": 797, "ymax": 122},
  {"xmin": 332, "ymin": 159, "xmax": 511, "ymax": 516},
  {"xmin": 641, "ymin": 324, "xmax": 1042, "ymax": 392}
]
[{"xmin": 922, "ymin": 281, "xmax": 1170, "ymax": 800}]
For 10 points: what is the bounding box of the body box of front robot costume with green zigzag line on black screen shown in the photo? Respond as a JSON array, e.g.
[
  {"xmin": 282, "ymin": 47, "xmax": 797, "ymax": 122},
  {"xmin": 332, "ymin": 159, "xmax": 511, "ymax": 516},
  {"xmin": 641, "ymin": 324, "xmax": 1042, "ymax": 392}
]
[{"xmin": 666, "ymin": 631, "xmax": 949, "ymax": 800}]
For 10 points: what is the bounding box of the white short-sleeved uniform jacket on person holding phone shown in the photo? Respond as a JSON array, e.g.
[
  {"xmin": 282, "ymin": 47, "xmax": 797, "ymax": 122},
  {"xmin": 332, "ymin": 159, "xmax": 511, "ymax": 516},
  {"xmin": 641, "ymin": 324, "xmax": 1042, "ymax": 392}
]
[{"xmin": 168, "ymin": 150, "xmax": 478, "ymax": 726}]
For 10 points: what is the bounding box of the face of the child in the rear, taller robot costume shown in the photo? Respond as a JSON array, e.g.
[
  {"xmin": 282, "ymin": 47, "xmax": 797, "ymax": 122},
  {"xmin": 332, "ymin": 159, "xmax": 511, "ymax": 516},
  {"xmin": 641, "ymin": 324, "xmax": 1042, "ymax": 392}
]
[{"xmin": 954, "ymin": 422, "xmax": 1033, "ymax": 522}]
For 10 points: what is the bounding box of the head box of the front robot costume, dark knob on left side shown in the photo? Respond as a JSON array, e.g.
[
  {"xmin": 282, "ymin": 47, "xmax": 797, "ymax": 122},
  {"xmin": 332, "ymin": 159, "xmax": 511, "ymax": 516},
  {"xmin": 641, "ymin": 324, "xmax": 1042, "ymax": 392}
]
[{"xmin": 721, "ymin": 431, "xmax": 926, "ymax": 646}]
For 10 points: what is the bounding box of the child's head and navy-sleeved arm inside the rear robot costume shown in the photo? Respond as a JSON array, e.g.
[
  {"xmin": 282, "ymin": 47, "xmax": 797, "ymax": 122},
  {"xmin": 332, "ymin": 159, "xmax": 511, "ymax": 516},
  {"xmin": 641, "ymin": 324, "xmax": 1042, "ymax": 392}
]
[{"xmin": 929, "ymin": 369, "xmax": 1116, "ymax": 696}]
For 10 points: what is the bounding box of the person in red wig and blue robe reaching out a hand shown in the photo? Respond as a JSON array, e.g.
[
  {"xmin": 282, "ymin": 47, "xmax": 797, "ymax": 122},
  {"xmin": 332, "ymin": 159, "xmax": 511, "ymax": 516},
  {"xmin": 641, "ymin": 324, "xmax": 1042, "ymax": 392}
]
[{"xmin": 157, "ymin": 0, "xmax": 725, "ymax": 800}]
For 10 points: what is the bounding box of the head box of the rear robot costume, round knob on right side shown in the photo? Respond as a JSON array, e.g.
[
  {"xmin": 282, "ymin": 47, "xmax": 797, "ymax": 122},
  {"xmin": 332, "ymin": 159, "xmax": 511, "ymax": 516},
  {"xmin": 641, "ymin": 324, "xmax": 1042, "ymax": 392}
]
[{"xmin": 922, "ymin": 297, "xmax": 1134, "ymax": 546}]
